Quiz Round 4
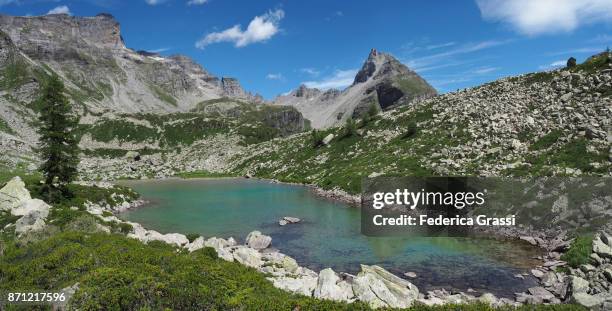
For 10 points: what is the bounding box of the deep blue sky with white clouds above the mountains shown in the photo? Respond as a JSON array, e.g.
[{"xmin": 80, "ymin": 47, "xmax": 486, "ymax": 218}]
[{"xmin": 0, "ymin": 0, "xmax": 612, "ymax": 98}]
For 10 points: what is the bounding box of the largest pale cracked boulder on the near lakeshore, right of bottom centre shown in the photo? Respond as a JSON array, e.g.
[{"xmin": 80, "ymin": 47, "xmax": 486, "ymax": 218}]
[{"xmin": 353, "ymin": 265, "xmax": 419, "ymax": 308}]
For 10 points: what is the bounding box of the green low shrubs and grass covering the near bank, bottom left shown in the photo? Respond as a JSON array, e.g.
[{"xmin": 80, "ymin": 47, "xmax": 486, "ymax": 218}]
[{"xmin": 0, "ymin": 232, "xmax": 584, "ymax": 310}]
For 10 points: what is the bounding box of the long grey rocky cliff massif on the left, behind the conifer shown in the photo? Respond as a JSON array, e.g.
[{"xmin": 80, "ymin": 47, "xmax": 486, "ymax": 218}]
[{"xmin": 0, "ymin": 14, "xmax": 278, "ymax": 164}]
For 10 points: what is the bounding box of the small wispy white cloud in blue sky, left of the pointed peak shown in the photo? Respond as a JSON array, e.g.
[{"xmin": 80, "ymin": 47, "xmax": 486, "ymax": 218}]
[{"xmin": 196, "ymin": 9, "xmax": 285, "ymax": 49}]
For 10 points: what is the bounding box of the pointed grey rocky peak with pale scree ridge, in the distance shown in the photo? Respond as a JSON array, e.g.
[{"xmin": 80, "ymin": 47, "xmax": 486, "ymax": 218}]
[{"xmin": 274, "ymin": 49, "xmax": 437, "ymax": 128}]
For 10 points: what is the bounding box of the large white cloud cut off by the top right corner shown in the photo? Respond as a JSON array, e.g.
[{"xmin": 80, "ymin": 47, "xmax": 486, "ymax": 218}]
[{"xmin": 476, "ymin": 0, "xmax": 612, "ymax": 36}]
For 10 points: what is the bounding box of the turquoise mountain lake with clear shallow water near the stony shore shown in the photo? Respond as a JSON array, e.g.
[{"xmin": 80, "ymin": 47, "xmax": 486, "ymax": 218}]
[{"xmin": 120, "ymin": 179, "xmax": 539, "ymax": 297}]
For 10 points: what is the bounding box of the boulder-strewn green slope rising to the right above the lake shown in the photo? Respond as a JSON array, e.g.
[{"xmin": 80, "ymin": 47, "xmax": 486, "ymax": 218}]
[{"xmin": 232, "ymin": 52, "xmax": 612, "ymax": 194}]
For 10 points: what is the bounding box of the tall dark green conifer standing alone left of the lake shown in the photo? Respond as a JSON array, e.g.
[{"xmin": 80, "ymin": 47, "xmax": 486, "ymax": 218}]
[{"xmin": 38, "ymin": 75, "xmax": 79, "ymax": 202}]
